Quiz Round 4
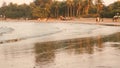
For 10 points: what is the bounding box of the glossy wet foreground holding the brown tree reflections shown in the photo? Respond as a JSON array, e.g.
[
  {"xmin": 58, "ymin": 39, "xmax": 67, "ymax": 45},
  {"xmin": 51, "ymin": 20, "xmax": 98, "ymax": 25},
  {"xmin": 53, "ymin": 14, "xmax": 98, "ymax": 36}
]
[{"xmin": 0, "ymin": 33, "xmax": 120, "ymax": 68}]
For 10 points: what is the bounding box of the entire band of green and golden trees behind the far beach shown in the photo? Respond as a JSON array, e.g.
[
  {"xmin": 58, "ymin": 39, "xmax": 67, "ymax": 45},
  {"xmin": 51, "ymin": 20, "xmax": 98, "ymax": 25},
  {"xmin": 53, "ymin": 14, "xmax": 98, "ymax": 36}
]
[{"xmin": 0, "ymin": 0, "xmax": 120, "ymax": 19}]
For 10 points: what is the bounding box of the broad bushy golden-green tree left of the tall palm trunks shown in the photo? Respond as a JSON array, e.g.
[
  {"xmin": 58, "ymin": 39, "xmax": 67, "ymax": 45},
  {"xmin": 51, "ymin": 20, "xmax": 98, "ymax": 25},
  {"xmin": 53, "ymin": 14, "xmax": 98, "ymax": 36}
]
[{"xmin": 34, "ymin": 0, "xmax": 52, "ymax": 17}]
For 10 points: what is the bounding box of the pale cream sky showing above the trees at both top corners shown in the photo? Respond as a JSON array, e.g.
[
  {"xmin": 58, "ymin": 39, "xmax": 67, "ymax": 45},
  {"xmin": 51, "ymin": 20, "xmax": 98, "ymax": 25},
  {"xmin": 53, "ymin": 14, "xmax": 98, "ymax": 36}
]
[{"xmin": 0, "ymin": 0, "xmax": 117, "ymax": 6}]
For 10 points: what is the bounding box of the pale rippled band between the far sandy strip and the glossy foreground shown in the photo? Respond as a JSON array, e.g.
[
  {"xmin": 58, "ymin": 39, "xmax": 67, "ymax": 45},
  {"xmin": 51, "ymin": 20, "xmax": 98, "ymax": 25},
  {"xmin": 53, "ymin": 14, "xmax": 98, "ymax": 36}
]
[{"xmin": 0, "ymin": 19, "xmax": 120, "ymax": 43}]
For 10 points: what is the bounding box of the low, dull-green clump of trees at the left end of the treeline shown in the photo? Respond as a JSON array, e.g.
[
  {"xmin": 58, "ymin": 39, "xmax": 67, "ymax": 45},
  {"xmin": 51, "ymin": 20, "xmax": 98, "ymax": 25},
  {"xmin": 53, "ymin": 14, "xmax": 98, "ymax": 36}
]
[{"xmin": 0, "ymin": 3, "xmax": 32, "ymax": 18}]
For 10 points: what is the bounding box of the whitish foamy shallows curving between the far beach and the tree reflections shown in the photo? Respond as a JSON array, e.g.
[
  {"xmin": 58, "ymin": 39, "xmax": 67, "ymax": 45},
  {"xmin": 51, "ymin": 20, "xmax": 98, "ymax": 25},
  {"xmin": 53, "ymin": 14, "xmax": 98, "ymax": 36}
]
[{"xmin": 0, "ymin": 22, "xmax": 120, "ymax": 42}]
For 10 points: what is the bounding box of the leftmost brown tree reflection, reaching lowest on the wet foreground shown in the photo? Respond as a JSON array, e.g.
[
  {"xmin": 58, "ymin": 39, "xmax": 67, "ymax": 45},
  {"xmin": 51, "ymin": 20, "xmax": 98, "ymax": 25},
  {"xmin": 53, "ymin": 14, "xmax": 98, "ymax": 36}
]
[{"xmin": 35, "ymin": 43, "xmax": 55, "ymax": 63}]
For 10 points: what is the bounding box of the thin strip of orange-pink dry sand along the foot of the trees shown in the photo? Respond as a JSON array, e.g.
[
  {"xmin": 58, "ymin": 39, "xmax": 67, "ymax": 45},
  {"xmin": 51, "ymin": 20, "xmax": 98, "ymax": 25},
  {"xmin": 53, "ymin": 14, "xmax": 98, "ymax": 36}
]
[{"xmin": 0, "ymin": 18, "xmax": 120, "ymax": 26}]
